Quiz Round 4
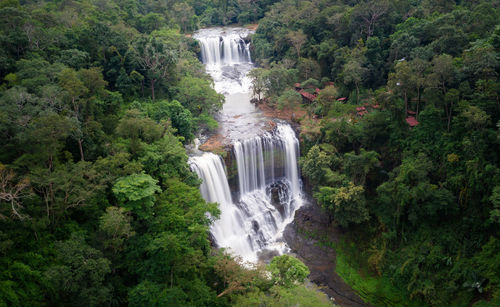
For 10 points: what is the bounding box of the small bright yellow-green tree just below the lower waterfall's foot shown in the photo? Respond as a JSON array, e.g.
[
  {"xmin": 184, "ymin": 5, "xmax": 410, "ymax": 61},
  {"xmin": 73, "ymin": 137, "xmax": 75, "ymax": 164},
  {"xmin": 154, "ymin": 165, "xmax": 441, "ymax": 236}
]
[{"xmin": 269, "ymin": 255, "xmax": 310, "ymax": 288}]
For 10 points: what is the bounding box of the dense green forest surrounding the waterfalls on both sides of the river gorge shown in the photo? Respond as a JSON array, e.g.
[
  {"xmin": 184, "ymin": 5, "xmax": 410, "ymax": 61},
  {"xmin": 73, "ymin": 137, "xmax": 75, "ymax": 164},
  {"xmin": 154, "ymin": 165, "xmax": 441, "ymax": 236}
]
[{"xmin": 0, "ymin": 0, "xmax": 500, "ymax": 307}]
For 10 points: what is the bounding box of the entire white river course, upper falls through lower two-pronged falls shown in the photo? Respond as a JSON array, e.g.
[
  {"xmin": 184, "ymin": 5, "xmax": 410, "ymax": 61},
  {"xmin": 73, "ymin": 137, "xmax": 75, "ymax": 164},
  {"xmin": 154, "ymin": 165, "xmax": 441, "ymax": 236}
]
[{"xmin": 189, "ymin": 27, "xmax": 304, "ymax": 263}]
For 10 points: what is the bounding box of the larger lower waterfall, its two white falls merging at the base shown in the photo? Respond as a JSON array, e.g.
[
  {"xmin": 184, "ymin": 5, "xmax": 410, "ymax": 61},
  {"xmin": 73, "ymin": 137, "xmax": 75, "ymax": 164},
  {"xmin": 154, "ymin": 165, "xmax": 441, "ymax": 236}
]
[{"xmin": 189, "ymin": 124, "xmax": 302, "ymax": 262}]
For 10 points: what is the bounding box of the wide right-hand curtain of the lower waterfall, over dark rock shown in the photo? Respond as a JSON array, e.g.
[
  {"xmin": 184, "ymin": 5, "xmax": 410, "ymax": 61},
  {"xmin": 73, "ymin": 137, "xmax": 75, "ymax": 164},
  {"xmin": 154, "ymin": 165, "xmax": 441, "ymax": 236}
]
[{"xmin": 233, "ymin": 124, "xmax": 302, "ymax": 258}]
